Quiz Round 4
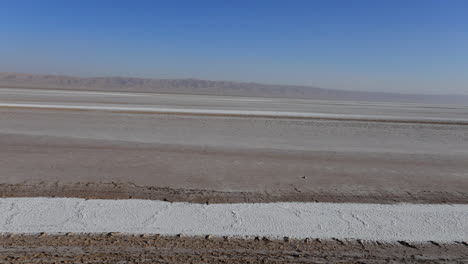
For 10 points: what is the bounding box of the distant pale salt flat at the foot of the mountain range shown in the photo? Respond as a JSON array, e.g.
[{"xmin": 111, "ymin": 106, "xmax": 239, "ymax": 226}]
[{"xmin": 0, "ymin": 88, "xmax": 468, "ymax": 119}]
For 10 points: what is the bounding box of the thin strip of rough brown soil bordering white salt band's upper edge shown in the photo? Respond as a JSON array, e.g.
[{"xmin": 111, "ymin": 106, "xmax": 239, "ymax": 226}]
[{"xmin": 0, "ymin": 182, "xmax": 468, "ymax": 204}]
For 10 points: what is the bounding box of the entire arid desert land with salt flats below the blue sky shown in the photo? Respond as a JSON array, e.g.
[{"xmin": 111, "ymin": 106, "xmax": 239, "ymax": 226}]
[{"xmin": 0, "ymin": 77, "xmax": 468, "ymax": 263}]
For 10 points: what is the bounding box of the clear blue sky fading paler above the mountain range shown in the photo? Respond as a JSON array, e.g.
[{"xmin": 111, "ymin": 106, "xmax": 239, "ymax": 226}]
[{"xmin": 0, "ymin": 0, "xmax": 468, "ymax": 94}]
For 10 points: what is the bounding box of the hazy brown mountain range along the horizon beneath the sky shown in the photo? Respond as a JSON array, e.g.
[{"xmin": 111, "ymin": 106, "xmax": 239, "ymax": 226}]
[{"xmin": 0, "ymin": 73, "xmax": 468, "ymax": 105}]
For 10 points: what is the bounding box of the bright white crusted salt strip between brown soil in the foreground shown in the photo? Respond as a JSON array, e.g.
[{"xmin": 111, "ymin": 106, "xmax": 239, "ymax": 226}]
[{"xmin": 0, "ymin": 198, "xmax": 468, "ymax": 242}]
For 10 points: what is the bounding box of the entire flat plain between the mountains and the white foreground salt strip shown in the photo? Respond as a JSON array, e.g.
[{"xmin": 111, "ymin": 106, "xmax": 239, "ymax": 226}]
[{"xmin": 0, "ymin": 89, "xmax": 468, "ymax": 203}]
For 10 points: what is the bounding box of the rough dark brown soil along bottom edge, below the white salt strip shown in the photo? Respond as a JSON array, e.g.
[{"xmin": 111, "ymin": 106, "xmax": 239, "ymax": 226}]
[{"xmin": 0, "ymin": 233, "xmax": 468, "ymax": 264}]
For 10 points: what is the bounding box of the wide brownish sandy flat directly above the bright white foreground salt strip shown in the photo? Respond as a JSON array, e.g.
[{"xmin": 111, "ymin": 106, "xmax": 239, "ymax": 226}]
[{"xmin": 0, "ymin": 134, "xmax": 468, "ymax": 203}]
